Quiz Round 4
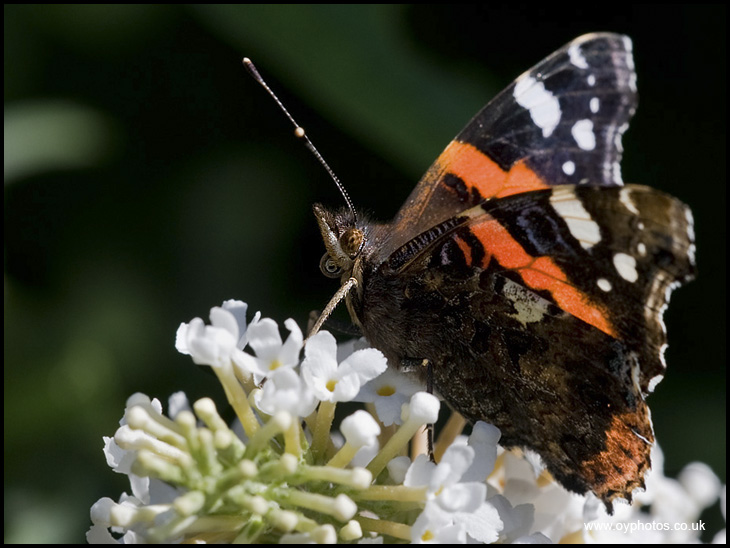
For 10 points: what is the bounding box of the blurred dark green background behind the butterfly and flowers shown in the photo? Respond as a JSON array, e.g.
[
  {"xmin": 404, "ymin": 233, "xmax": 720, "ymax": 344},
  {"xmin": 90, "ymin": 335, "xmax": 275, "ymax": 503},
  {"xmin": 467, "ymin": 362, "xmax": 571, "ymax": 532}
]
[{"xmin": 4, "ymin": 4, "xmax": 726, "ymax": 542}]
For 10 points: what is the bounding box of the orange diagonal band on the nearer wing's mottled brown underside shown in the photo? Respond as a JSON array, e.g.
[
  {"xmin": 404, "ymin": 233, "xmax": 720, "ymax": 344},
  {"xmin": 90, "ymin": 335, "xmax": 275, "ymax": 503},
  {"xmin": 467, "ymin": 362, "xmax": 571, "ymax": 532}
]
[{"xmin": 470, "ymin": 219, "xmax": 618, "ymax": 338}]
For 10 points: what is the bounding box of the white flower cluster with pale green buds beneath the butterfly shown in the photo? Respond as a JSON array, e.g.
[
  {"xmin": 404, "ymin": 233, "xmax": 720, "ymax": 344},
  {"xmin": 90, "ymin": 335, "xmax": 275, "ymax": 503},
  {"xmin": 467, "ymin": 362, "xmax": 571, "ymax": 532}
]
[{"xmin": 87, "ymin": 301, "xmax": 724, "ymax": 544}]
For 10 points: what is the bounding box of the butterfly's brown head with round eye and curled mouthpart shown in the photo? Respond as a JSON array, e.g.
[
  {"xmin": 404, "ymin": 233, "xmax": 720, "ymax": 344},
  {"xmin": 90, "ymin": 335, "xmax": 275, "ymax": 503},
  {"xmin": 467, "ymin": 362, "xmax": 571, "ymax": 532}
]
[{"xmin": 314, "ymin": 204, "xmax": 365, "ymax": 278}]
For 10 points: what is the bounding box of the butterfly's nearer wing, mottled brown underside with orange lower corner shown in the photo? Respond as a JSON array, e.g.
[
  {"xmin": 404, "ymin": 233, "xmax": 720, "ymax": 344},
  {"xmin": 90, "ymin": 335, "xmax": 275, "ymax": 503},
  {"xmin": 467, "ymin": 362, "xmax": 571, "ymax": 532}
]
[{"xmin": 363, "ymin": 185, "xmax": 695, "ymax": 507}]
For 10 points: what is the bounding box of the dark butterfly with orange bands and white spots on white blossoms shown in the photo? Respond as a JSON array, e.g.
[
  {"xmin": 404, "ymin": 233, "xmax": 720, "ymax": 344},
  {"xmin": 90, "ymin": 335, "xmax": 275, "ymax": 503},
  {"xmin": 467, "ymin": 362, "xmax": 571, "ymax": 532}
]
[{"xmin": 314, "ymin": 33, "xmax": 696, "ymax": 512}]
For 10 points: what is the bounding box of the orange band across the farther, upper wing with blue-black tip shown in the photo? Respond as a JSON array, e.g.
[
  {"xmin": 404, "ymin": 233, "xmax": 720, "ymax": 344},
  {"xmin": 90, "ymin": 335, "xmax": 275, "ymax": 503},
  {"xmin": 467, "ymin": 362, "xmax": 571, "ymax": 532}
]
[{"xmin": 437, "ymin": 141, "xmax": 548, "ymax": 198}]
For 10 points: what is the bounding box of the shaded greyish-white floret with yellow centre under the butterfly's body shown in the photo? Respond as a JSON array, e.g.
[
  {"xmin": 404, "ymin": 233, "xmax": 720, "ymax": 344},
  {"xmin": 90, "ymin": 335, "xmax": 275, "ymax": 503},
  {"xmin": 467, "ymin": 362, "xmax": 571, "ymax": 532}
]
[{"xmin": 354, "ymin": 367, "xmax": 423, "ymax": 426}]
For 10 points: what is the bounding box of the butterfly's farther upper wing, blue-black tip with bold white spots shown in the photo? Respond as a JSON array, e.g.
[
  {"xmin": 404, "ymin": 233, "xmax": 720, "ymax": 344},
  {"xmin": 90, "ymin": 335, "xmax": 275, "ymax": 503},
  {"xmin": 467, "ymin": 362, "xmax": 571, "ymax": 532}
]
[{"xmin": 378, "ymin": 33, "xmax": 638, "ymax": 259}]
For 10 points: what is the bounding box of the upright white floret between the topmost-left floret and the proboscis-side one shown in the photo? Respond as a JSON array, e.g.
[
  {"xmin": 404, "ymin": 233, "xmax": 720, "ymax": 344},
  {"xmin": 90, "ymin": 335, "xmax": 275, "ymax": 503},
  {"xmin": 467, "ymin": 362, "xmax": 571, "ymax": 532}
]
[{"xmin": 241, "ymin": 318, "xmax": 304, "ymax": 383}]
